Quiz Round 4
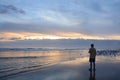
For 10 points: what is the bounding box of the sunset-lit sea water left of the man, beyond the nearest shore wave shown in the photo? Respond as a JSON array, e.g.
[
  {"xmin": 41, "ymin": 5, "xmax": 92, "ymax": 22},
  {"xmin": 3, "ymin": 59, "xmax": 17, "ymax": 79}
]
[{"xmin": 0, "ymin": 49, "xmax": 88, "ymax": 72}]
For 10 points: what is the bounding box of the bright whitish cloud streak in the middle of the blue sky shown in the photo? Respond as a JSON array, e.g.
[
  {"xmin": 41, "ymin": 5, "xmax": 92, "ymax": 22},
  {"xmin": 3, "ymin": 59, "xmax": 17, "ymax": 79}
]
[{"xmin": 38, "ymin": 10, "xmax": 79, "ymax": 26}]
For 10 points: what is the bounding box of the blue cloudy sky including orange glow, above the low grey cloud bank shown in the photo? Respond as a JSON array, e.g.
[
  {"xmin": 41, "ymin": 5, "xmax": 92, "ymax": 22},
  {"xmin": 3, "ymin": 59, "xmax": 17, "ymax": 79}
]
[{"xmin": 0, "ymin": 0, "xmax": 120, "ymax": 42}]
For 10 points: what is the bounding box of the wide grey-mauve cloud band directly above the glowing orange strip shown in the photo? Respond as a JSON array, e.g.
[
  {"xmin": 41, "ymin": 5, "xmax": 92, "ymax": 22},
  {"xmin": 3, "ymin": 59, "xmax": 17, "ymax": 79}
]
[{"xmin": 0, "ymin": 19, "xmax": 120, "ymax": 36}]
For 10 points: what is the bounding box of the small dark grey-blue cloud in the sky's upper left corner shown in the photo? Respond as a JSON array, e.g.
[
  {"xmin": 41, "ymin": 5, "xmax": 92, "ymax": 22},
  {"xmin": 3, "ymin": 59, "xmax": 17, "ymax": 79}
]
[{"xmin": 0, "ymin": 5, "xmax": 25, "ymax": 14}]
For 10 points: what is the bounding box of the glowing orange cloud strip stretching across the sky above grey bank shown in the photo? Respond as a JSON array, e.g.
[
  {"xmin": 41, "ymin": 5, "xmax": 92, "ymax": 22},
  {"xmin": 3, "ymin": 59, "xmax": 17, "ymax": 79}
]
[{"xmin": 0, "ymin": 32, "xmax": 120, "ymax": 41}]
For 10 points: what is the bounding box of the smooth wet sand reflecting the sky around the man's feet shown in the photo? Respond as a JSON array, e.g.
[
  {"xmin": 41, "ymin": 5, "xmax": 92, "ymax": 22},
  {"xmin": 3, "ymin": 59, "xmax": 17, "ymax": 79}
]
[{"xmin": 0, "ymin": 58, "xmax": 120, "ymax": 80}]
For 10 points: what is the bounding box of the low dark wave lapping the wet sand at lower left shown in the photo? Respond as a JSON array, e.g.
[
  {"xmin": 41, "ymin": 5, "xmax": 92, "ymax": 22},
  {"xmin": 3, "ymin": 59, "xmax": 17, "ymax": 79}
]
[{"xmin": 0, "ymin": 63, "xmax": 55, "ymax": 79}]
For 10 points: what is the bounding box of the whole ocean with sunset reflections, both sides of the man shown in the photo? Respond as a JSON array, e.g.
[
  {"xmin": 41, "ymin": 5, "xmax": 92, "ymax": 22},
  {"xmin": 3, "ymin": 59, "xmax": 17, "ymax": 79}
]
[{"xmin": 0, "ymin": 48, "xmax": 120, "ymax": 77}]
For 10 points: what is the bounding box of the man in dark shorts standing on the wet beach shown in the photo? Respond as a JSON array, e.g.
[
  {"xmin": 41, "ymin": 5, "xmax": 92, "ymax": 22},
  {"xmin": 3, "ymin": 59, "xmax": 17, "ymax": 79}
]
[{"xmin": 89, "ymin": 44, "xmax": 96, "ymax": 71}]
